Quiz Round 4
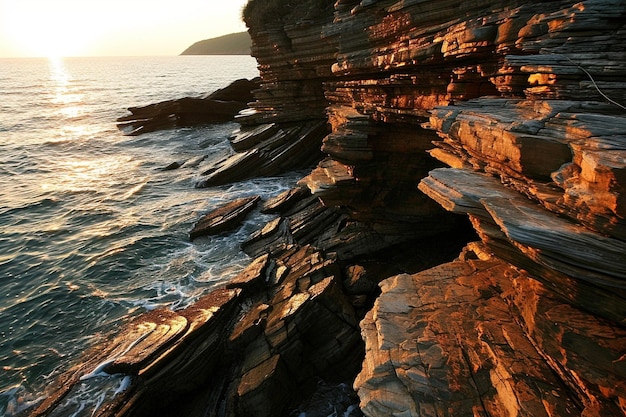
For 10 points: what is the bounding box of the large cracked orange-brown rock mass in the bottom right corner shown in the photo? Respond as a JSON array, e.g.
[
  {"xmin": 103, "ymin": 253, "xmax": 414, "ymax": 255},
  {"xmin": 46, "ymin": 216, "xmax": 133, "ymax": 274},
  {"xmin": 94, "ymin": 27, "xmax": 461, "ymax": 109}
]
[{"xmin": 355, "ymin": 247, "xmax": 626, "ymax": 417}]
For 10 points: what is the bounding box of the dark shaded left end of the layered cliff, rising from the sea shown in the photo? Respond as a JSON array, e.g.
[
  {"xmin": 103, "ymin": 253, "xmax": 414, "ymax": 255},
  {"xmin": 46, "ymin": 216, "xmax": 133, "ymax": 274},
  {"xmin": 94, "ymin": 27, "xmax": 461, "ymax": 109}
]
[{"xmin": 198, "ymin": 0, "xmax": 336, "ymax": 187}]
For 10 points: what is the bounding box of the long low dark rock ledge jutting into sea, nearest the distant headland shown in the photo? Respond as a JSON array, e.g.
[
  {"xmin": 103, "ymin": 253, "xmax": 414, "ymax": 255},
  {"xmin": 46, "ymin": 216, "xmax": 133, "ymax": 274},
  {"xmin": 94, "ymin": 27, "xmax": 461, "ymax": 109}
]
[{"xmin": 117, "ymin": 79, "xmax": 258, "ymax": 136}]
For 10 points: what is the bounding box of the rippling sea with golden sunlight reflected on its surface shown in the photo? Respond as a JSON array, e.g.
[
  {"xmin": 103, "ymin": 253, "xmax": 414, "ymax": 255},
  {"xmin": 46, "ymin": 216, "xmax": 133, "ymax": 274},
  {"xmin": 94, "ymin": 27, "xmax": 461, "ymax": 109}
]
[{"xmin": 0, "ymin": 56, "xmax": 300, "ymax": 416}]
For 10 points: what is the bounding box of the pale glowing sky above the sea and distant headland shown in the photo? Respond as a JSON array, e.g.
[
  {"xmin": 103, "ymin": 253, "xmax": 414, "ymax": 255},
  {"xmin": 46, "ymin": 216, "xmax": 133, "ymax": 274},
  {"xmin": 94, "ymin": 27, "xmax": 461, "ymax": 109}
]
[{"xmin": 0, "ymin": 0, "xmax": 247, "ymax": 57}]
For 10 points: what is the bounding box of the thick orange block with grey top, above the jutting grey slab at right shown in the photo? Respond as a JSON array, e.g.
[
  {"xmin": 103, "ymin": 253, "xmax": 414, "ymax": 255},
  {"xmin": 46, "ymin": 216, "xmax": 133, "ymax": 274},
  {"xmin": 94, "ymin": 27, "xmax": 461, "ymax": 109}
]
[{"xmin": 429, "ymin": 99, "xmax": 626, "ymax": 240}]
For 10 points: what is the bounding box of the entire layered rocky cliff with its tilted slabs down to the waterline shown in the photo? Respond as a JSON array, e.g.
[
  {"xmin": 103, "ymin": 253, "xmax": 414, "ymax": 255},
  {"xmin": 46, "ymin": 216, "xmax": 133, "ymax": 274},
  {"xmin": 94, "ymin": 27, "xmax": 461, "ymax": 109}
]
[{"xmin": 33, "ymin": 0, "xmax": 626, "ymax": 417}]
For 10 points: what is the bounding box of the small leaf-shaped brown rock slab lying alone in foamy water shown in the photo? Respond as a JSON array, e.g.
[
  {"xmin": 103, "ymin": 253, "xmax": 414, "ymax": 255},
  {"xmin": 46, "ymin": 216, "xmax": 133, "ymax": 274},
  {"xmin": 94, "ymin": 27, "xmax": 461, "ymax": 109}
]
[{"xmin": 189, "ymin": 196, "xmax": 261, "ymax": 240}]
